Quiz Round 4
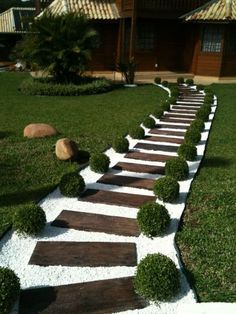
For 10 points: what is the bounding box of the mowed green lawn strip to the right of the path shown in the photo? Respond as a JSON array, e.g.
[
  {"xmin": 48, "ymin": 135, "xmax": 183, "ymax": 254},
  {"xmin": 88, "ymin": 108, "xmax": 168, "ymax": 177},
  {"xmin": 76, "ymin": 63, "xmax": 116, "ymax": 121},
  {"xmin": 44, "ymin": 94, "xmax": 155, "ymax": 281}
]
[{"xmin": 177, "ymin": 84, "xmax": 236, "ymax": 302}]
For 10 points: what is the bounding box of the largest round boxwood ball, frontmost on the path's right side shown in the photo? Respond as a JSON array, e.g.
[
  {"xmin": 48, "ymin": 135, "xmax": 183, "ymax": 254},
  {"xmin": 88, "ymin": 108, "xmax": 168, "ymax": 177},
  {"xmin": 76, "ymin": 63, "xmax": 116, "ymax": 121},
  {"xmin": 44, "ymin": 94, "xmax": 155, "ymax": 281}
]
[{"xmin": 134, "ymin": 253, "xmax": 180, "ymax": 301}]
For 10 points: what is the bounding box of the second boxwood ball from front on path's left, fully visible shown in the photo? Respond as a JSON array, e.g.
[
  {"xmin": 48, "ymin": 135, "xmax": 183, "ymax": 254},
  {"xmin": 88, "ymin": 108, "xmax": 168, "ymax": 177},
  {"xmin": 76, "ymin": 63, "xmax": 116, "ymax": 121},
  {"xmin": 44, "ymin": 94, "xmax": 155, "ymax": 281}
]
[{"xmin": 12, "ymin": 204, "xmax": 46, "ymax": 236}]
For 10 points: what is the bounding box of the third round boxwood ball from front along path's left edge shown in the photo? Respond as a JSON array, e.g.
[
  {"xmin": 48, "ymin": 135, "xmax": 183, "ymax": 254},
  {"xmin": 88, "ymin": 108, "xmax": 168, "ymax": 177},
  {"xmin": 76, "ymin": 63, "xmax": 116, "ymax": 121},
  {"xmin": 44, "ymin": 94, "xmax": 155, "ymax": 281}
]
[{"xmin": 59, "ymin": 172, "xmax": 85, "ymax": 197}]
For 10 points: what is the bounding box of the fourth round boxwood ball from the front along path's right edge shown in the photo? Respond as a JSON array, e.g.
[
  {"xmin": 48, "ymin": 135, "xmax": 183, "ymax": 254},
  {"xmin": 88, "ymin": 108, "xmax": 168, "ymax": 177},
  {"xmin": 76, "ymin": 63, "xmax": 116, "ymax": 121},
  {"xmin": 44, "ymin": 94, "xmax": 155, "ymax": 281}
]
[{"xmin": 165, "ymin": 157, "xmax": 189, "ymax": 181}]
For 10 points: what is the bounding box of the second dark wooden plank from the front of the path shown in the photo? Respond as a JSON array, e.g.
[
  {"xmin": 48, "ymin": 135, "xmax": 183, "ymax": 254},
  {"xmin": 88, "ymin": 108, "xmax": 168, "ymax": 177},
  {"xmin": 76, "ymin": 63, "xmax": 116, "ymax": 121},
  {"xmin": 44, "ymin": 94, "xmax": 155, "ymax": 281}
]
[{"xmin": 29, "ymin": 241, "xmax": 137, "ymax": 267}]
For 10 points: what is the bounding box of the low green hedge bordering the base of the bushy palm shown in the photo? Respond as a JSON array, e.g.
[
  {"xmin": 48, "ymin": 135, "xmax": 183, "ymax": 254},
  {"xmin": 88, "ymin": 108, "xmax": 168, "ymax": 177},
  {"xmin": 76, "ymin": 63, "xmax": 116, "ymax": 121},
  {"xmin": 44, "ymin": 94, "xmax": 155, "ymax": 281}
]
[{"xmin": 20, "ymin": 78, "xmax": 112, "ymax": 96}]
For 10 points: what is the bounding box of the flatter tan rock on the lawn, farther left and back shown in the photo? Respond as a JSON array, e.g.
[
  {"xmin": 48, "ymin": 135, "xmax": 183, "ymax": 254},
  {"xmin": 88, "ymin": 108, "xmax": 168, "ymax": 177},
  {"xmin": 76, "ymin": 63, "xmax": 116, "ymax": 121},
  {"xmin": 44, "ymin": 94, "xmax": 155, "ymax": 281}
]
[{"xmin": 24, "ymin": 123, "xmax": 58, "ymax": 138}]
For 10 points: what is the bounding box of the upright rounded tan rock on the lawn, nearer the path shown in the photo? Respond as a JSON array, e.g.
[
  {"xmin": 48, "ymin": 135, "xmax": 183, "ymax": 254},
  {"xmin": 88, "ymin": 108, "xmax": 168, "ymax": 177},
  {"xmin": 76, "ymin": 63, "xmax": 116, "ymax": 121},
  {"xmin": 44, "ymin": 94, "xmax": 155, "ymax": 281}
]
[{"xmin": 56, "ymin": 138, "xmax": 78, "ymax": 160}]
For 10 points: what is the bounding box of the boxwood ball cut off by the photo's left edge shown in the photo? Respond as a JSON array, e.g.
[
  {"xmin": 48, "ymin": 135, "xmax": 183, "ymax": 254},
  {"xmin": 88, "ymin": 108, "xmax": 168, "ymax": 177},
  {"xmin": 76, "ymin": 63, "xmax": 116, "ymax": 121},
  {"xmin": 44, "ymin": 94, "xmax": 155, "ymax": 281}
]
[{"xmin": 0, "ymin": 267, "xmax": 20, "ymax": 314}]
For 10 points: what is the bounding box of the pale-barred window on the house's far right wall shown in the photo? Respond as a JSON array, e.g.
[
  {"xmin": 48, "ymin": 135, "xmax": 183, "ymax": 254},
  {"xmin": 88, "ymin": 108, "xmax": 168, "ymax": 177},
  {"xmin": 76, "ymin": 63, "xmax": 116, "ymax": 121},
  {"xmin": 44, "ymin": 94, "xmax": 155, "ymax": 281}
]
[{"xmin": 202, "ymin": 25, "xmax": 223, "ymax": 52}]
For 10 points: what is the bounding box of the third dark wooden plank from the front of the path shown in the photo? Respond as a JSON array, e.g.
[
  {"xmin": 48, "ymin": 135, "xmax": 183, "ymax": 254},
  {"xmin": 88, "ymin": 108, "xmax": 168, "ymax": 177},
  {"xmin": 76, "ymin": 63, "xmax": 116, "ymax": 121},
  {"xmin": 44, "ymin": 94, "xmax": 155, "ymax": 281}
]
[{"xmin": 51, "ymin": 210, "xmax": 140, "ymax": 237}]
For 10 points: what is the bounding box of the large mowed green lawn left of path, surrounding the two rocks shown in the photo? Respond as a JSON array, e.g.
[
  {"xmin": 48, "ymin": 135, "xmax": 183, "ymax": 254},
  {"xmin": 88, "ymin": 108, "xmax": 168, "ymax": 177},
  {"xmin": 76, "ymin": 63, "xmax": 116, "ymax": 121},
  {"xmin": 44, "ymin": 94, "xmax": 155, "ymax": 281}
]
[{"xmin": 0, "ymin": 73, "xmax": 166, "ymax": 235}]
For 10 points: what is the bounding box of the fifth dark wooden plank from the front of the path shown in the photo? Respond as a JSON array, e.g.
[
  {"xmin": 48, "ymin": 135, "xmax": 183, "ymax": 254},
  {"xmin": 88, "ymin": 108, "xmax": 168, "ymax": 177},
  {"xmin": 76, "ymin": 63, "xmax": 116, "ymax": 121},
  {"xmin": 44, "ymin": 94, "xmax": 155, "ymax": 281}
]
[{"xmin": 97, "ymin": 174, "xmax": 155, "ymax": 191}]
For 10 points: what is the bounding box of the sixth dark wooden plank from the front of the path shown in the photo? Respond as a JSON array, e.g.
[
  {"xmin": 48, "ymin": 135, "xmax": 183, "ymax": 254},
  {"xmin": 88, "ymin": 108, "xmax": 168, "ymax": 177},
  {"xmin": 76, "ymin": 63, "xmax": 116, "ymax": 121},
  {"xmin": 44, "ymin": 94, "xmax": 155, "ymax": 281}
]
[{"xmin": 112, "ymin": 162, "xmax": 165, "ymax": 174}]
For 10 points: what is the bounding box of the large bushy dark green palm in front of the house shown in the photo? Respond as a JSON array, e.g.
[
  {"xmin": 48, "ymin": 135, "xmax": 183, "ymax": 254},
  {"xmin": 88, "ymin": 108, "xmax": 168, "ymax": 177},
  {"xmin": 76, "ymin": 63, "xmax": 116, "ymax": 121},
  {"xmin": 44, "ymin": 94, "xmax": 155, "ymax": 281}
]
[{"xmin": 16, "ymin": 13, "xmax": 98, "ymax": 82}]
